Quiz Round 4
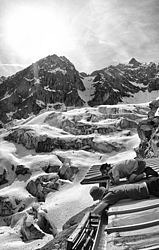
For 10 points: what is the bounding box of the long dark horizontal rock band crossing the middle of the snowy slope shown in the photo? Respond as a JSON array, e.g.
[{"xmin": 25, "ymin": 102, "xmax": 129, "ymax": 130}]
[{"xmin": 5, "ymin": 128, "xmax": 124, "ymax": 153}]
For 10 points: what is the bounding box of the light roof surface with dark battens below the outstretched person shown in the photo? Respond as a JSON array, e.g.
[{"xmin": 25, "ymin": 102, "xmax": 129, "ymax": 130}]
[{"xmin": 106, "ymin": 188, "xmax": 159, "ymax": 250}]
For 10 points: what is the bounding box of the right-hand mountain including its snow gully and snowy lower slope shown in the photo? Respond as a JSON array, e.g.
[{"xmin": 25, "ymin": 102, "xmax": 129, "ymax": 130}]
[{"xmin": 78, "ymin": 58, "xmax": 159, "ymax": 106}]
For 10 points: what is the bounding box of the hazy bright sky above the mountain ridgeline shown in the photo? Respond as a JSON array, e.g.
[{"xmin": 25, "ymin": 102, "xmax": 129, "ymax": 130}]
[{"xmin": 0, "ymin": 0, "xmax": 159, "ymax": 76}]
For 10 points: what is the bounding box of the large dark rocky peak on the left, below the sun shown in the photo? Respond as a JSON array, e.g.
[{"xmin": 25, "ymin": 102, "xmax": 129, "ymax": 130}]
[{"xmin": 0, "ymin": 55, "xmax": 85, "ymax": 122}]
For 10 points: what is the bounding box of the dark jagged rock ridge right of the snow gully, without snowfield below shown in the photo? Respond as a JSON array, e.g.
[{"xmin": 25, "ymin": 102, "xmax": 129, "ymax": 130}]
[{"xmin": 85, "ymin": 58, "xmax": 159, "ymax": 106}]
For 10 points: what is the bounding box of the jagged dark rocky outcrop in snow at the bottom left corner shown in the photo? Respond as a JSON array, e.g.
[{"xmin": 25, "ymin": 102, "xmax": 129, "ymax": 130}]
[{"xmin": 0, "ymin": 196, "xmax": 58, "ymax": 242}]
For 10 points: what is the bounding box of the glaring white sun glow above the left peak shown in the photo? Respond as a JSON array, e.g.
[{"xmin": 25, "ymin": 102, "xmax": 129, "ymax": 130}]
[{"xmin": 5, "ymin": 6, "xmax": 71, "ymax": 58}]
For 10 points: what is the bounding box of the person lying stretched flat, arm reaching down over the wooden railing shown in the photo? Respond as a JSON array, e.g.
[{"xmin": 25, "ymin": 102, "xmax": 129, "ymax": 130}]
[{"xmin": 90, "ymin": 177, "xmax": 159, "ymax": 214}]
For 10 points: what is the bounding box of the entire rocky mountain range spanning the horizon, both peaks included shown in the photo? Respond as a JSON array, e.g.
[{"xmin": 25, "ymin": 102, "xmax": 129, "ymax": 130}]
[{"xmin": 0, "ymin": 55, "xmax": 159, "ymax": 123}]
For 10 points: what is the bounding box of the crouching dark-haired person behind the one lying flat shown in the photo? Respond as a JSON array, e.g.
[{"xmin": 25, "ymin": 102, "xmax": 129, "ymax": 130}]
[{"xmin": 100, "ymin": 159, "xmax": 158, "ymax": 185}]
